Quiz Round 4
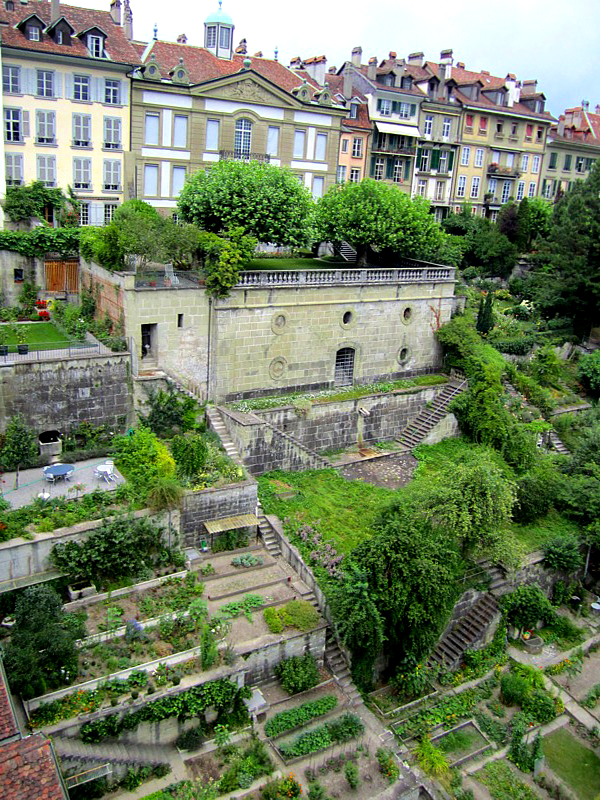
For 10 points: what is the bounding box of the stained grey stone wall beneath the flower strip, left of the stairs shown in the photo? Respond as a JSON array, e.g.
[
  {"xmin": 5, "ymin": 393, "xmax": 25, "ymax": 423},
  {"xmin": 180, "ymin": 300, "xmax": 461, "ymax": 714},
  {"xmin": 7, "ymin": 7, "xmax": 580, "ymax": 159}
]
[{"xmin": 247, "ymin": 386, "xmax": 444, "ymax": 458}]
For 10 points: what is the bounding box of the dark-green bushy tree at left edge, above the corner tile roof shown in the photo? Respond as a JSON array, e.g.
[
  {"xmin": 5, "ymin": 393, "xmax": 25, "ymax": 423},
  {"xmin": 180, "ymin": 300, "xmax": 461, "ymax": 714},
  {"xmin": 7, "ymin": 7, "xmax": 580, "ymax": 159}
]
[{"xmin": 4, "ymin": 585, "xmax": 84, "ymax": 698}]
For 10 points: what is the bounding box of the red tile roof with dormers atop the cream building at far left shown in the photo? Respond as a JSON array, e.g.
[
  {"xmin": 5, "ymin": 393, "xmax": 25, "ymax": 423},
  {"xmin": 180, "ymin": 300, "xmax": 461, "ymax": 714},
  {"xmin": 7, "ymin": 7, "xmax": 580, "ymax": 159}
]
[{"xmin": 0, "ymin": 0, "xmax": 139, "ymax": 65}]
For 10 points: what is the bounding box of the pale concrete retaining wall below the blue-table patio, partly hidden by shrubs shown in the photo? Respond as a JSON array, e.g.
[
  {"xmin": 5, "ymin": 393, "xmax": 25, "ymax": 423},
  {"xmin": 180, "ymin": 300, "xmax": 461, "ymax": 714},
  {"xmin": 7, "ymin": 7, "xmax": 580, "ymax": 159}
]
[{"xmin": 0, "ymin": 509, "xmax": 179, "ymax": 593}]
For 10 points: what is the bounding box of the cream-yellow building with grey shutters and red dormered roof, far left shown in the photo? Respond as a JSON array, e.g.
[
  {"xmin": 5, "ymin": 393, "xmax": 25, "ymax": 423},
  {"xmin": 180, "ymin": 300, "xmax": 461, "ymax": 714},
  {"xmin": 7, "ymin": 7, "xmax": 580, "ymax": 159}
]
[{"xmin": 2, "ymin": 0, "xmax": 138, "ymax": 225}]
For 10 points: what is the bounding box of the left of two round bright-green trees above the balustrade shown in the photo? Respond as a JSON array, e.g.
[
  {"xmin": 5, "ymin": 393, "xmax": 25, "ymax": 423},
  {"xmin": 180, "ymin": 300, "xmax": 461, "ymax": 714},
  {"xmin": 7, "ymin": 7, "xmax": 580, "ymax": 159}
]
[{"xmin": 178, "ymin": 161, "xmax": 314, "ymax": 247}]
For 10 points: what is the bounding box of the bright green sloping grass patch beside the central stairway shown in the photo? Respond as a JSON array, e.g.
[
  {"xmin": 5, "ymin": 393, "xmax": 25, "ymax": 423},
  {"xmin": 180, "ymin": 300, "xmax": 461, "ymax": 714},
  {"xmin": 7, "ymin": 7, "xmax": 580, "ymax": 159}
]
[{"xmin": 258, "ymin": 469, "xmax": 395, "ymax": 553}]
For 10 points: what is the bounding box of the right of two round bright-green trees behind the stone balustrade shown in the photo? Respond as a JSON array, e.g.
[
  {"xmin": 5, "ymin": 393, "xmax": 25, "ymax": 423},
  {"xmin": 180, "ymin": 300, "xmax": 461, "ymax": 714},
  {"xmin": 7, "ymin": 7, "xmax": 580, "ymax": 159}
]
[{"xmin": 317, "ymin": 179, "xmax": 460, "ymax": 265}]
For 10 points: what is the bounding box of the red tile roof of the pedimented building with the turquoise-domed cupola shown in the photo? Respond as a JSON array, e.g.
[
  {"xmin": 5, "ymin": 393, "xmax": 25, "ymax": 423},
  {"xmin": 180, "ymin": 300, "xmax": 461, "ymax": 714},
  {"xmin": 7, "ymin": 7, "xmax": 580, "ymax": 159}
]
[{"xmin": 136, "ymin": 41, "xmax": 332, "ymax": 97}]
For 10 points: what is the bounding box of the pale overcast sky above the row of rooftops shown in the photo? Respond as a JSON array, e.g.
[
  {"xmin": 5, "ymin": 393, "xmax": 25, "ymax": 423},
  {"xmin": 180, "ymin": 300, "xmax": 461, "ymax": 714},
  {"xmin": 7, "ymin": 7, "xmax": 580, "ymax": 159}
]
[{"xmin": 94, "ymin": 0, "xmax": 600, "ymax": 114}]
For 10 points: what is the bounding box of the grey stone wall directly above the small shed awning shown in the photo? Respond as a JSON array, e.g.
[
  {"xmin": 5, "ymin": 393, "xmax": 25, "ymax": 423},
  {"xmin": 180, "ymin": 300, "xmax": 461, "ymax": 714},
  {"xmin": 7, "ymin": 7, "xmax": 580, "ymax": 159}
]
[{"xmin": 181, "ymin": 479, "xmax": 258, "ymax": 547}]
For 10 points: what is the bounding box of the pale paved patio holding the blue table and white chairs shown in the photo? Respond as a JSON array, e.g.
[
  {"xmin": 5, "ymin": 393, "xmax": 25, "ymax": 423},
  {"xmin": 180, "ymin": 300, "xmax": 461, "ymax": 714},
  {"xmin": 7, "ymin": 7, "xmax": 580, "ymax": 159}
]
[{"xmin": 0, "ymin": 453, "xmax": 125, "ymax": 508}]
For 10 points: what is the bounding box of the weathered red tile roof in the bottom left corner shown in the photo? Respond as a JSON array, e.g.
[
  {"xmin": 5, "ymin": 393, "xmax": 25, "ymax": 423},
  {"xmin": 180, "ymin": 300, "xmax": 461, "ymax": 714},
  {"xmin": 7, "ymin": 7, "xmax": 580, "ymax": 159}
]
[{"xmin": 0, "ymin": 733, "xmax": 68, "ymax": 800}]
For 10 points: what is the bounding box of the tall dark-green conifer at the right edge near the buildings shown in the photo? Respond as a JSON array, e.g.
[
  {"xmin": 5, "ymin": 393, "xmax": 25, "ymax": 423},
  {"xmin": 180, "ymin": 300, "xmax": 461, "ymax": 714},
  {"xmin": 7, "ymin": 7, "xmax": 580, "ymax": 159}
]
[{"xmin": 530, "ymin": 160, "xmax": 600, "ymax": 335}]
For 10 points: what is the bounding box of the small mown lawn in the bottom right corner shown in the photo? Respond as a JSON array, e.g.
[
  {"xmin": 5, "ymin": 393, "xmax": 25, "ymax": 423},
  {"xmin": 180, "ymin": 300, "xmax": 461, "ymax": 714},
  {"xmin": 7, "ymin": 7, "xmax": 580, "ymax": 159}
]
[{"xmin": 544, "ymin": 728, "xmax": 600, "ymax": 800}]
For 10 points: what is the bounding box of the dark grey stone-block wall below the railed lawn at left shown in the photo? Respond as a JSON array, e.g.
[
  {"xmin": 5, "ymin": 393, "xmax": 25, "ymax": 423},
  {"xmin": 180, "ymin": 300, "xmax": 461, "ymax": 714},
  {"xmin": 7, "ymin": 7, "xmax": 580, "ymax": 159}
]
[{"xmin": 0, "ymin": 354, "xmax": 132, "ymax": 432}]
